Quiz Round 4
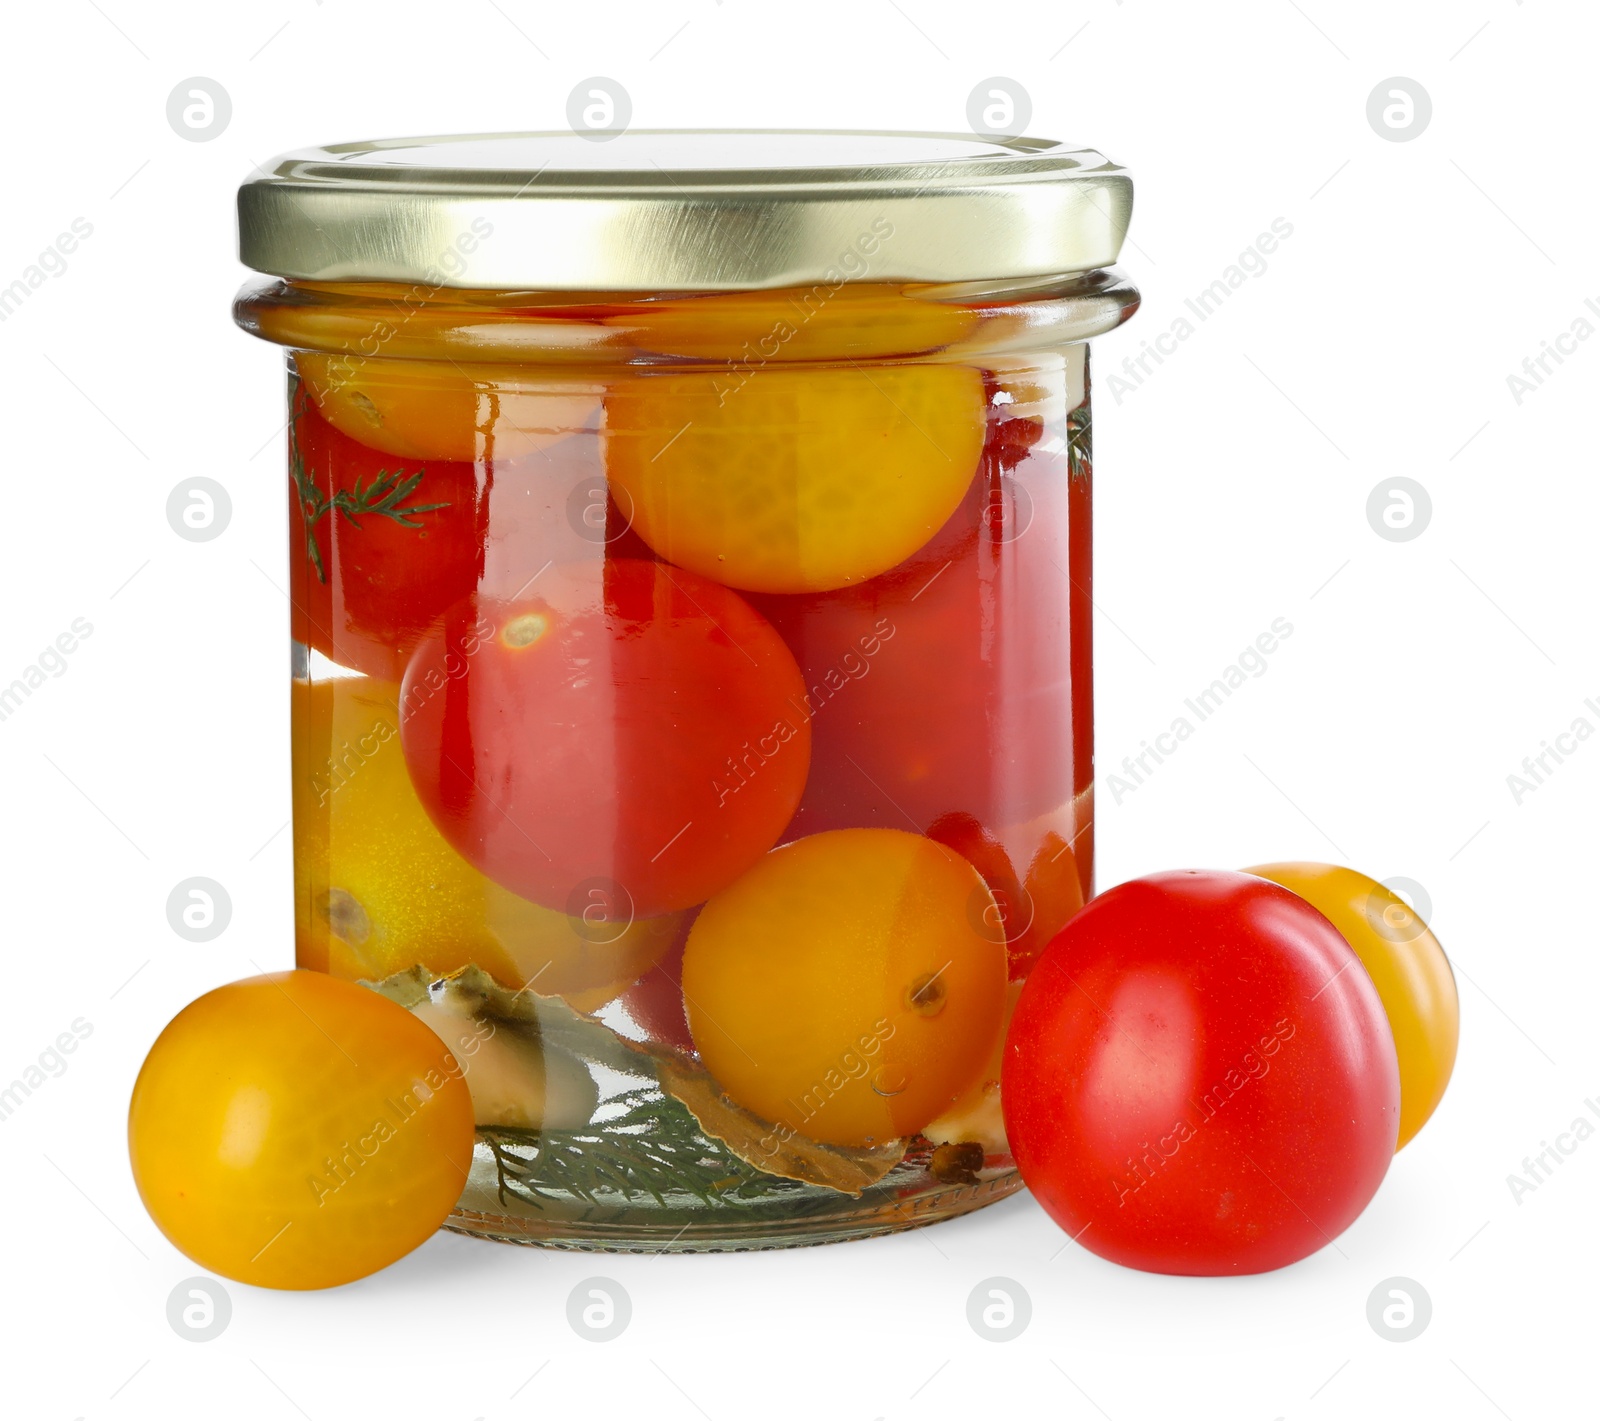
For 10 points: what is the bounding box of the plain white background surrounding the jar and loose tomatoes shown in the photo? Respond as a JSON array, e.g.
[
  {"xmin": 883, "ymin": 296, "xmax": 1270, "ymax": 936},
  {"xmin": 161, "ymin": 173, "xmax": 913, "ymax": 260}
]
[{"xmin": 0, "ymin": 0, "xmax": 1600, "ymax": 1421}]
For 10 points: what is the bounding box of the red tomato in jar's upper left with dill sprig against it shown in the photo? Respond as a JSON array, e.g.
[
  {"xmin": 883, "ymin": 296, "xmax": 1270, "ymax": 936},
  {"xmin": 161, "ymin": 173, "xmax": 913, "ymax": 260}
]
[{"xmin": 290, "ymin": 386, "xmax": 646, "ymax": 682}]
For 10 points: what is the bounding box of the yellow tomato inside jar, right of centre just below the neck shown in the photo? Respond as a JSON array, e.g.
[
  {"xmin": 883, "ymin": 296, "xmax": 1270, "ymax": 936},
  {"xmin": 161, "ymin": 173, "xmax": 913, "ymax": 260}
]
[{"xmin": 605, "ymin": 365, "xmax": 984, "ymax": 592}]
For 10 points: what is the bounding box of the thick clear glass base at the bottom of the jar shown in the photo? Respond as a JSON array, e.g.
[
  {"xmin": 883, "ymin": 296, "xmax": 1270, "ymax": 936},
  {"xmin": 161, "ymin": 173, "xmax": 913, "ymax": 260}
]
[{"xmin": 445, "ymin": 1139, "xmax": 1022, "ymax": 1253}]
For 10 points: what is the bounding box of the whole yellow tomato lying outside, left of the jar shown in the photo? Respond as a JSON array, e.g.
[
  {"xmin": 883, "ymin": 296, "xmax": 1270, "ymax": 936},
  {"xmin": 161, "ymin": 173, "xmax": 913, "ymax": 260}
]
[{"xmin": 128, "ymin": 971, "xmax": 474, "ymax": 1288}]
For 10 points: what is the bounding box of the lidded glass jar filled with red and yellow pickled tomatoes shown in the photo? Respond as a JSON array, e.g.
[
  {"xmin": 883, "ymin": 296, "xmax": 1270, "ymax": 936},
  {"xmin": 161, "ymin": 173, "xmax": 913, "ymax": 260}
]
[{"xmin": 237, "ymin": 133, "xmax": 1138, "ymax": 1250}]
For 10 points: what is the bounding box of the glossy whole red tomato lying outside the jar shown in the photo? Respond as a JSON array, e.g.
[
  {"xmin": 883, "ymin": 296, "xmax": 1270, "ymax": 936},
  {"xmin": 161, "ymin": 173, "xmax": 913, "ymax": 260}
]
[{"xmin": 1000, "ymin": 872, "xmax": 1400, "ymax": 1275}]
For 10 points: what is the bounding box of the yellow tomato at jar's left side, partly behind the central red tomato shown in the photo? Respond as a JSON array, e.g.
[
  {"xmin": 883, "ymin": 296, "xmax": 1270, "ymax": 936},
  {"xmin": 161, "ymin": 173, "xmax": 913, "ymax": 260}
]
[{"xmin": 291, "ymin": 677, "xmax": 682, "ymax": 1011}]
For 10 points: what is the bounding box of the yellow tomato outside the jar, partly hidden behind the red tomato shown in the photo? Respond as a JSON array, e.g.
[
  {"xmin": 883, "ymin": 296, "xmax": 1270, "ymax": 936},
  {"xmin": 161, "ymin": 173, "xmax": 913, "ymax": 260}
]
[{"xmin": 1245, "ymin": 863, "xmax": 1461, "ymax": 1151}]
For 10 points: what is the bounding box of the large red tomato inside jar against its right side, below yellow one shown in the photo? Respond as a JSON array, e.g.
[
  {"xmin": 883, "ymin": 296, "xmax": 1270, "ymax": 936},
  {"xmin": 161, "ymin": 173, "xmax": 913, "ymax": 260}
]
[{"xmin": 752, "ymin": 396, "xmax": 1086, "ymax": 834}]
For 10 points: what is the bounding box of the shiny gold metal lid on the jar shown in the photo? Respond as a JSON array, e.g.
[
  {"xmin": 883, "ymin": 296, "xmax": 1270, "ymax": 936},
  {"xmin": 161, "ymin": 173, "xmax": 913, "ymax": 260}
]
[{"xmin": 238, "ymin": 130, "xmax": 1133, "ymax": 291}]
